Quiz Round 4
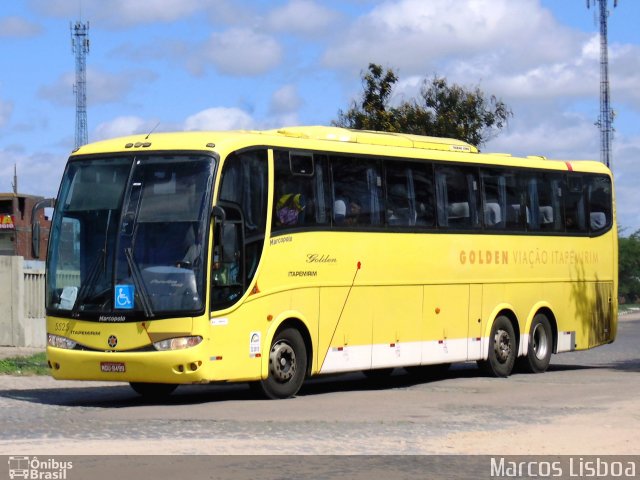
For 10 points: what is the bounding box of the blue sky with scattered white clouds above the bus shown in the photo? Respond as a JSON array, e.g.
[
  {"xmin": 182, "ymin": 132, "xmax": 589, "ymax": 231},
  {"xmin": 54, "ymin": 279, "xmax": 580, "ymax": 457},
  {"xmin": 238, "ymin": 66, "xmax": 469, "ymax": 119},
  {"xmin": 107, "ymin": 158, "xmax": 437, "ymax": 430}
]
[{"xmin": 0, "ymin": 0, "xmax": 640, "ymax": 233}]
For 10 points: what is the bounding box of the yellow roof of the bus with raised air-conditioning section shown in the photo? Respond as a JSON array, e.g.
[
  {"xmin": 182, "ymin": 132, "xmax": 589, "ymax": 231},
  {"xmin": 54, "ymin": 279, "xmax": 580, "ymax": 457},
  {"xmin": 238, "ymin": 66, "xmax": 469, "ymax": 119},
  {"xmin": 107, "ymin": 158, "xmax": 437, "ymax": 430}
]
[{"xmin": 72, "ymin": 126, "xmax": 608, "ymax": 172}]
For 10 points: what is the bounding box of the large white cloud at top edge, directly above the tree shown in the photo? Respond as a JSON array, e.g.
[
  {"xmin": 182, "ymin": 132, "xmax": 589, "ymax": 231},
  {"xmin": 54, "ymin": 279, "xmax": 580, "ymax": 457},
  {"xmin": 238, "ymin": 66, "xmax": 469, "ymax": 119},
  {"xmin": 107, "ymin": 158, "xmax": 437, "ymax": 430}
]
[{"xmin": 324, "ymin": 0, "xmax": 578, "ymax": 74}]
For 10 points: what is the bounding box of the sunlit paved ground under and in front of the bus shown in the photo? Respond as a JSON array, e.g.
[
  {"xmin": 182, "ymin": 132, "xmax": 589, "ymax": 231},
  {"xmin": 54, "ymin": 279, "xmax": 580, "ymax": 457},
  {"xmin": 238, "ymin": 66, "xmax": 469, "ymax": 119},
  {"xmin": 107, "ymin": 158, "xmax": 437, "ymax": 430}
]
[{"xmin": 0, "ymin": 320, "xmax": 640, "ymax": 458}]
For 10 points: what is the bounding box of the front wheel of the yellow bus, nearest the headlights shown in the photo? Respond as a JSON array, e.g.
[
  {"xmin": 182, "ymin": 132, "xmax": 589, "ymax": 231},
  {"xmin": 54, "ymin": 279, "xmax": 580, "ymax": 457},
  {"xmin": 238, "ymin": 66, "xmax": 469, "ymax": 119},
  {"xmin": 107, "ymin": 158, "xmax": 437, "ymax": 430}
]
[{"xmin": 260, "ymin": 328, "xmax": 307, "ymax": 400}]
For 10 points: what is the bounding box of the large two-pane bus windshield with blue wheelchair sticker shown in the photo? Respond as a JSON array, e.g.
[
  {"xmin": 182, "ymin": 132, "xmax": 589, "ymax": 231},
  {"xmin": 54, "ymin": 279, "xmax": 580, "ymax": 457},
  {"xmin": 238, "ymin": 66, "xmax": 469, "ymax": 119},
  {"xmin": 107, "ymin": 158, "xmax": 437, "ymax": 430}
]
[{"xmin": 46, "ymin": 155, "xmax": 213, "ymax": 321}]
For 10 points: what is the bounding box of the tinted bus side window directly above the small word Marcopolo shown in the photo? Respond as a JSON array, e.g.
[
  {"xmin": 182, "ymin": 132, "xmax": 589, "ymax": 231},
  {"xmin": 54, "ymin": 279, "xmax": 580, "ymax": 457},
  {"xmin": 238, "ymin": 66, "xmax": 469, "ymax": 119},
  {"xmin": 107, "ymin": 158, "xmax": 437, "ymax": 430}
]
[{"xmin": 331, "ymin": 157, "xmax": 383, "ymax": 227}]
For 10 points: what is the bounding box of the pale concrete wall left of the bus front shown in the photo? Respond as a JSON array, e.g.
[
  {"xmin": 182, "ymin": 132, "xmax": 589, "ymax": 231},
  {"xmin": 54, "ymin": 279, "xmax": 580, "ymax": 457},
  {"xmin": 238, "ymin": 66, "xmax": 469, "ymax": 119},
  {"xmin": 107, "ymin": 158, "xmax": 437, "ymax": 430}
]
[{"xmin": 0, "ymin": 256, "xmax": 47, "ymax": 347}]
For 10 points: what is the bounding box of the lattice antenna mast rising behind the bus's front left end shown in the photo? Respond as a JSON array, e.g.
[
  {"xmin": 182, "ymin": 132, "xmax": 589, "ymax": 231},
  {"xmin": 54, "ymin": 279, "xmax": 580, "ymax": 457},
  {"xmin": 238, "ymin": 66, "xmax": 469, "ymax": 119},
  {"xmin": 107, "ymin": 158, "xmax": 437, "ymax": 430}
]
[{"xmin": 71, "ymin": 20, "xmax": 89, "ymax": 148}]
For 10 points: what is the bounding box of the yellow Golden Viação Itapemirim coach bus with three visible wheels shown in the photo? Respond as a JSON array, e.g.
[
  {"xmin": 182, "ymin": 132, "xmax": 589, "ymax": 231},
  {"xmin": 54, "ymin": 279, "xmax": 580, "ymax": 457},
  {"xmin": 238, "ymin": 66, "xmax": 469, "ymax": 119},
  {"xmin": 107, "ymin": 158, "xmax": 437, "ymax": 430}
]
[{"xmin": 46, "ymin": 127, "xmax": 618, "ymax": 398}]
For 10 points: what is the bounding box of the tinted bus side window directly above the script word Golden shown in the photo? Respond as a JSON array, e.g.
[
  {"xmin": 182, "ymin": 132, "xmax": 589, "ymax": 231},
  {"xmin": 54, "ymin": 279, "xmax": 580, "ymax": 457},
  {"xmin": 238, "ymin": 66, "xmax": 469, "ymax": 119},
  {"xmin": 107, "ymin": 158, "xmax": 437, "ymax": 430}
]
[{"xmin": 385, "ymin": 161, "xmax": 435, "ymax": 227}]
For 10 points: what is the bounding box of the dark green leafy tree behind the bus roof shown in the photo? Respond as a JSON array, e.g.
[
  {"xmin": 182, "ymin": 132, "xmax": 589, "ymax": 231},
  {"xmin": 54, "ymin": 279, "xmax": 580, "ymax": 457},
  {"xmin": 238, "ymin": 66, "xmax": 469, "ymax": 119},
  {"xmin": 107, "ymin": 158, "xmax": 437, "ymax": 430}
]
[{"xmin": 332, "ymin": 63, "xmax": 513, "ymax": 145}]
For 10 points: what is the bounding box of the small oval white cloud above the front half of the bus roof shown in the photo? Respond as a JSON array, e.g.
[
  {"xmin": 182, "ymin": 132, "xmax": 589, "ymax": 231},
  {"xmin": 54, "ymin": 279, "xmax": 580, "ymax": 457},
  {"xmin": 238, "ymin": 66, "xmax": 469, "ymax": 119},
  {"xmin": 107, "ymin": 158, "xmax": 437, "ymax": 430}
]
[{"xmin": 199, "ymin": 28, "xmax": 282, "ymax": 76}]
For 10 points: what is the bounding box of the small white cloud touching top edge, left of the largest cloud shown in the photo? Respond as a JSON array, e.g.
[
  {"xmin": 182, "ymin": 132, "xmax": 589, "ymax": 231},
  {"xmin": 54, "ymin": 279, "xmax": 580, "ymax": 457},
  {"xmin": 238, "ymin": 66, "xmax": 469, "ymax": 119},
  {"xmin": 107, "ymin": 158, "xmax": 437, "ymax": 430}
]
[{"xmin": 266, "ymin": 0, "xmax": 341, "ymax": 36}]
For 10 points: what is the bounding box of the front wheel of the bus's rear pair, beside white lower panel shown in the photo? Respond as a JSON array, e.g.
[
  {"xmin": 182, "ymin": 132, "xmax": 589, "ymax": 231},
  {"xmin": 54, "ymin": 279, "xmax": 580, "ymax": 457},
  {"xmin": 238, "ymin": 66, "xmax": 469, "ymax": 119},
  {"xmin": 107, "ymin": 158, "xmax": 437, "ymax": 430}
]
[{"xmin": 478, "ymin": 315, "xmax": 518, "ymax": 377}]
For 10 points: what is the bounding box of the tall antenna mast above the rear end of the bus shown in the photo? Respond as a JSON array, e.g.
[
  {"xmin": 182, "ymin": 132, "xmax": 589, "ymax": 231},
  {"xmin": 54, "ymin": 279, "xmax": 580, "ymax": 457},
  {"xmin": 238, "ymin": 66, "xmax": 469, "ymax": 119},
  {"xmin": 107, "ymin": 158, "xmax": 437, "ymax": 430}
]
[{"xmin": 587, "ymin": 0, "xmax": 618, "ymax": 168}]
